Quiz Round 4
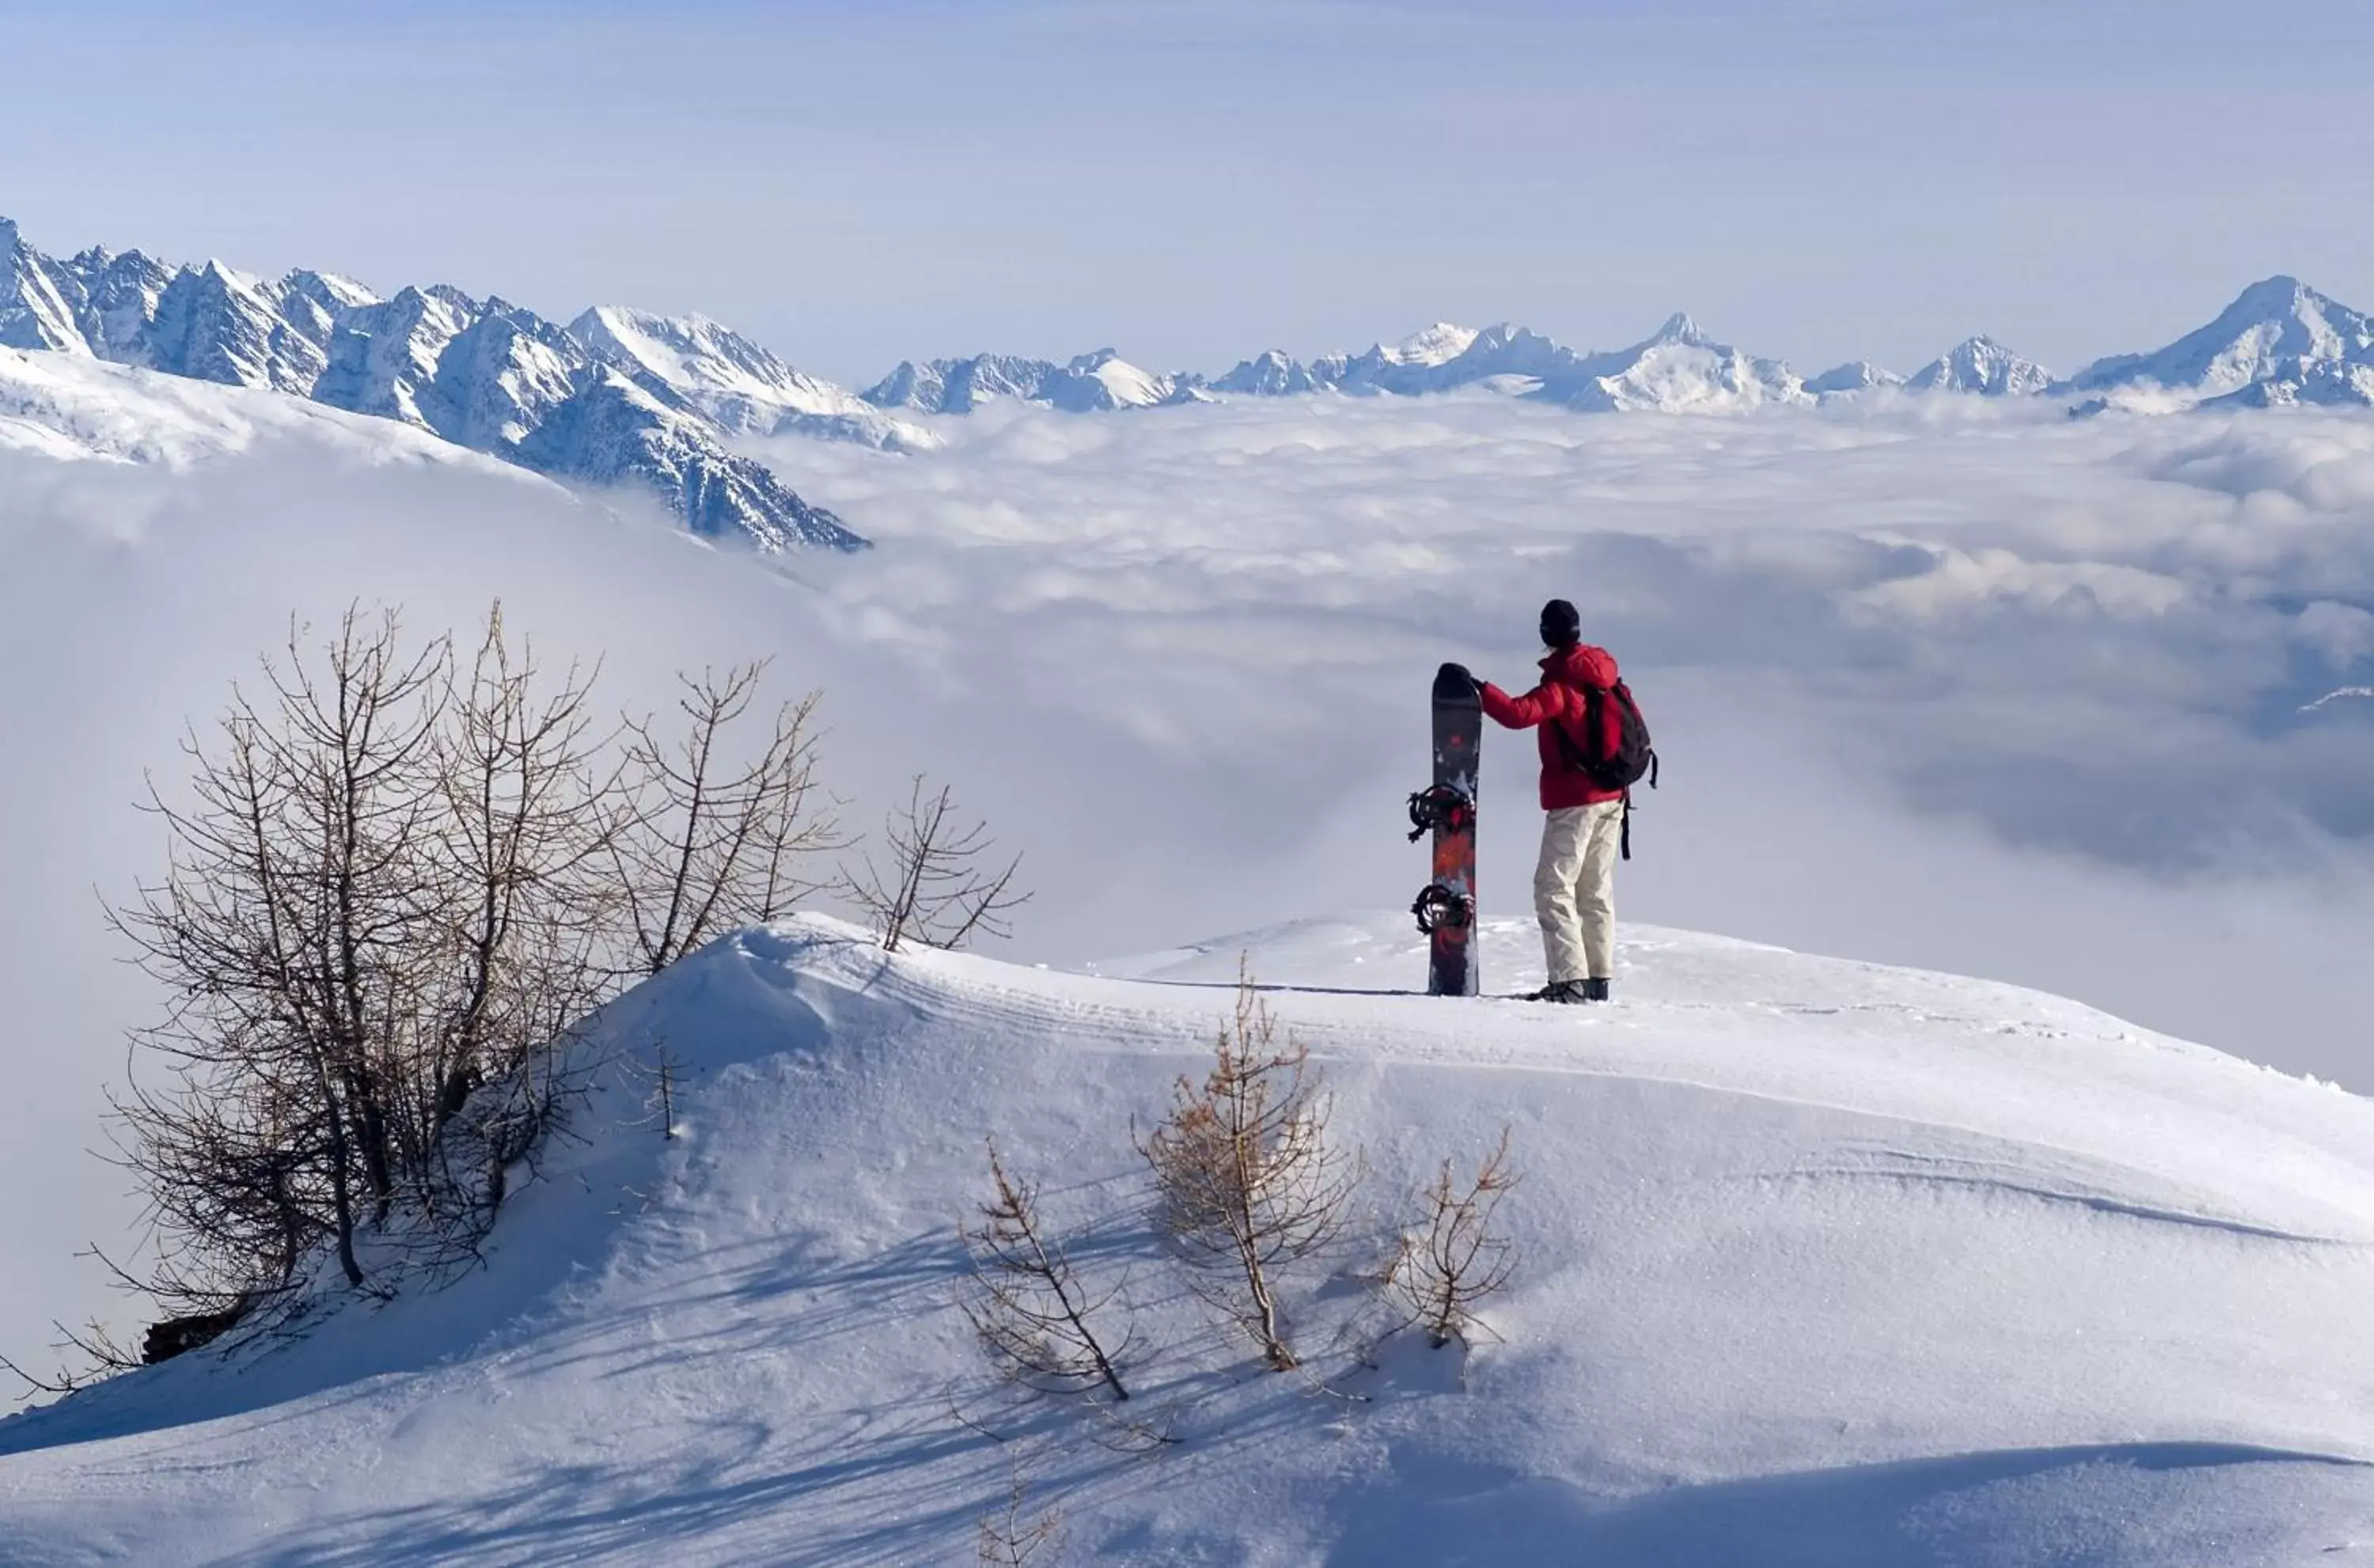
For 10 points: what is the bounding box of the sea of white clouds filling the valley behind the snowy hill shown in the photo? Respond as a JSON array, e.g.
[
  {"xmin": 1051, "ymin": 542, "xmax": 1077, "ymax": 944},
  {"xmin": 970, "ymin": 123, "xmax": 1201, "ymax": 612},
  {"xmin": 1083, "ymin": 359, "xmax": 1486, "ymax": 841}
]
[{"xmin": 0, "ymin": 394, "xmax": 2374, "ymax": 1359}]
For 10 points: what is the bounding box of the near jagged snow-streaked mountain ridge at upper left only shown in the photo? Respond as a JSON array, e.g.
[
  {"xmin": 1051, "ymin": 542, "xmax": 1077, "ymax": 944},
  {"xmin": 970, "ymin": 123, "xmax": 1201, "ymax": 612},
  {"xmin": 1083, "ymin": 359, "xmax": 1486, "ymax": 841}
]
[{"xmin": 0, "ymin": 218, "xmax": 893, "ymax": 551}]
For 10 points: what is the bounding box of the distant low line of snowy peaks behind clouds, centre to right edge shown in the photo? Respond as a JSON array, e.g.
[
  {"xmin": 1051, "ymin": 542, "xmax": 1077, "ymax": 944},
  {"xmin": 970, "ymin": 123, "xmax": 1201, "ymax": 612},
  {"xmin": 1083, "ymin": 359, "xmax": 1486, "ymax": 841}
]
[{"xmin": 864, "ymin": 278, "xmax": 2374, "ymax": 413}]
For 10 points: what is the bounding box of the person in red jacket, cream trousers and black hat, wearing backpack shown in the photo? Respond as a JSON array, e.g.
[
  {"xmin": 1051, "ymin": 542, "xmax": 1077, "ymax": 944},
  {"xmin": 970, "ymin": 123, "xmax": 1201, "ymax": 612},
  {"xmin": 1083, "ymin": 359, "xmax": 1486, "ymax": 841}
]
[{"xmin": 1477, "ymin": 598, "xmax": 1652, "ymax": 1001}]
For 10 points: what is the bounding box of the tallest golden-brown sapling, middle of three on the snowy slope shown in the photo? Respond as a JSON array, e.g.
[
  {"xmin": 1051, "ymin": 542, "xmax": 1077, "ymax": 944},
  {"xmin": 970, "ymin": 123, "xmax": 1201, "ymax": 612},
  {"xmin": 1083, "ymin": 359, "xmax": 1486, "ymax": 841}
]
[{"xmin": 1140, "ymin": 977, "xmax": 1363, "ymax": 1371}]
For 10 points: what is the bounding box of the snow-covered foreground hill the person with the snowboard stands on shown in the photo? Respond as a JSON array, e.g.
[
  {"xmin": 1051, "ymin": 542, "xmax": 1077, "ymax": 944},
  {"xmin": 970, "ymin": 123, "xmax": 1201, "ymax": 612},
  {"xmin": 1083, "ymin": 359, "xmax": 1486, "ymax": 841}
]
[{"xmin": 0, "ymin": 915, "xmax": 2374, "ymax": 1568}]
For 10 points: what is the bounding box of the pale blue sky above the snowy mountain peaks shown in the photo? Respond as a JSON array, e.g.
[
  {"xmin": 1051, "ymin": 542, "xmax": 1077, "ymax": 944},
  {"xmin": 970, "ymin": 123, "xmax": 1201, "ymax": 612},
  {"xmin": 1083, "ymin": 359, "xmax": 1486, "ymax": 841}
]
[{"xmin": 0, "ymin": 0, "xmax": 2374, "ymax": 382}]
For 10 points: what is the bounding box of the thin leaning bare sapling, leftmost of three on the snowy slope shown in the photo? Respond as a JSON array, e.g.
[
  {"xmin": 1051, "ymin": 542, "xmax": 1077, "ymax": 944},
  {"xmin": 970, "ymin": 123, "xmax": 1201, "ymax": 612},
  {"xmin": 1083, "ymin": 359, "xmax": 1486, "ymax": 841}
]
[{"xmin": 961, "ymin": 1138, "xmax": 1130, "ymax": 1399}]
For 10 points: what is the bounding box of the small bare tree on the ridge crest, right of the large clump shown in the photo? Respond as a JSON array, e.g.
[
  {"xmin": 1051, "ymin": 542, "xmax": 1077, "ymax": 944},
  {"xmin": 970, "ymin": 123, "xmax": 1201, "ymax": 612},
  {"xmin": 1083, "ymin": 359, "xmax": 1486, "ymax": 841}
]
[{"xmin": 840, "ymin": 774, "xmax": 1030, "ymax": 953}]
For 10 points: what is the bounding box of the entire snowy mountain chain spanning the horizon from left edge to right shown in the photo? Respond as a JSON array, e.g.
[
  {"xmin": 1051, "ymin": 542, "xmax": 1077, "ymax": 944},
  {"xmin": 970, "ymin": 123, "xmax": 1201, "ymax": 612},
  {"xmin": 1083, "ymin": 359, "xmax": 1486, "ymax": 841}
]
[{"xmin": 0, "ymin": 207, "xmax": 2374, "ymax": 498}]
